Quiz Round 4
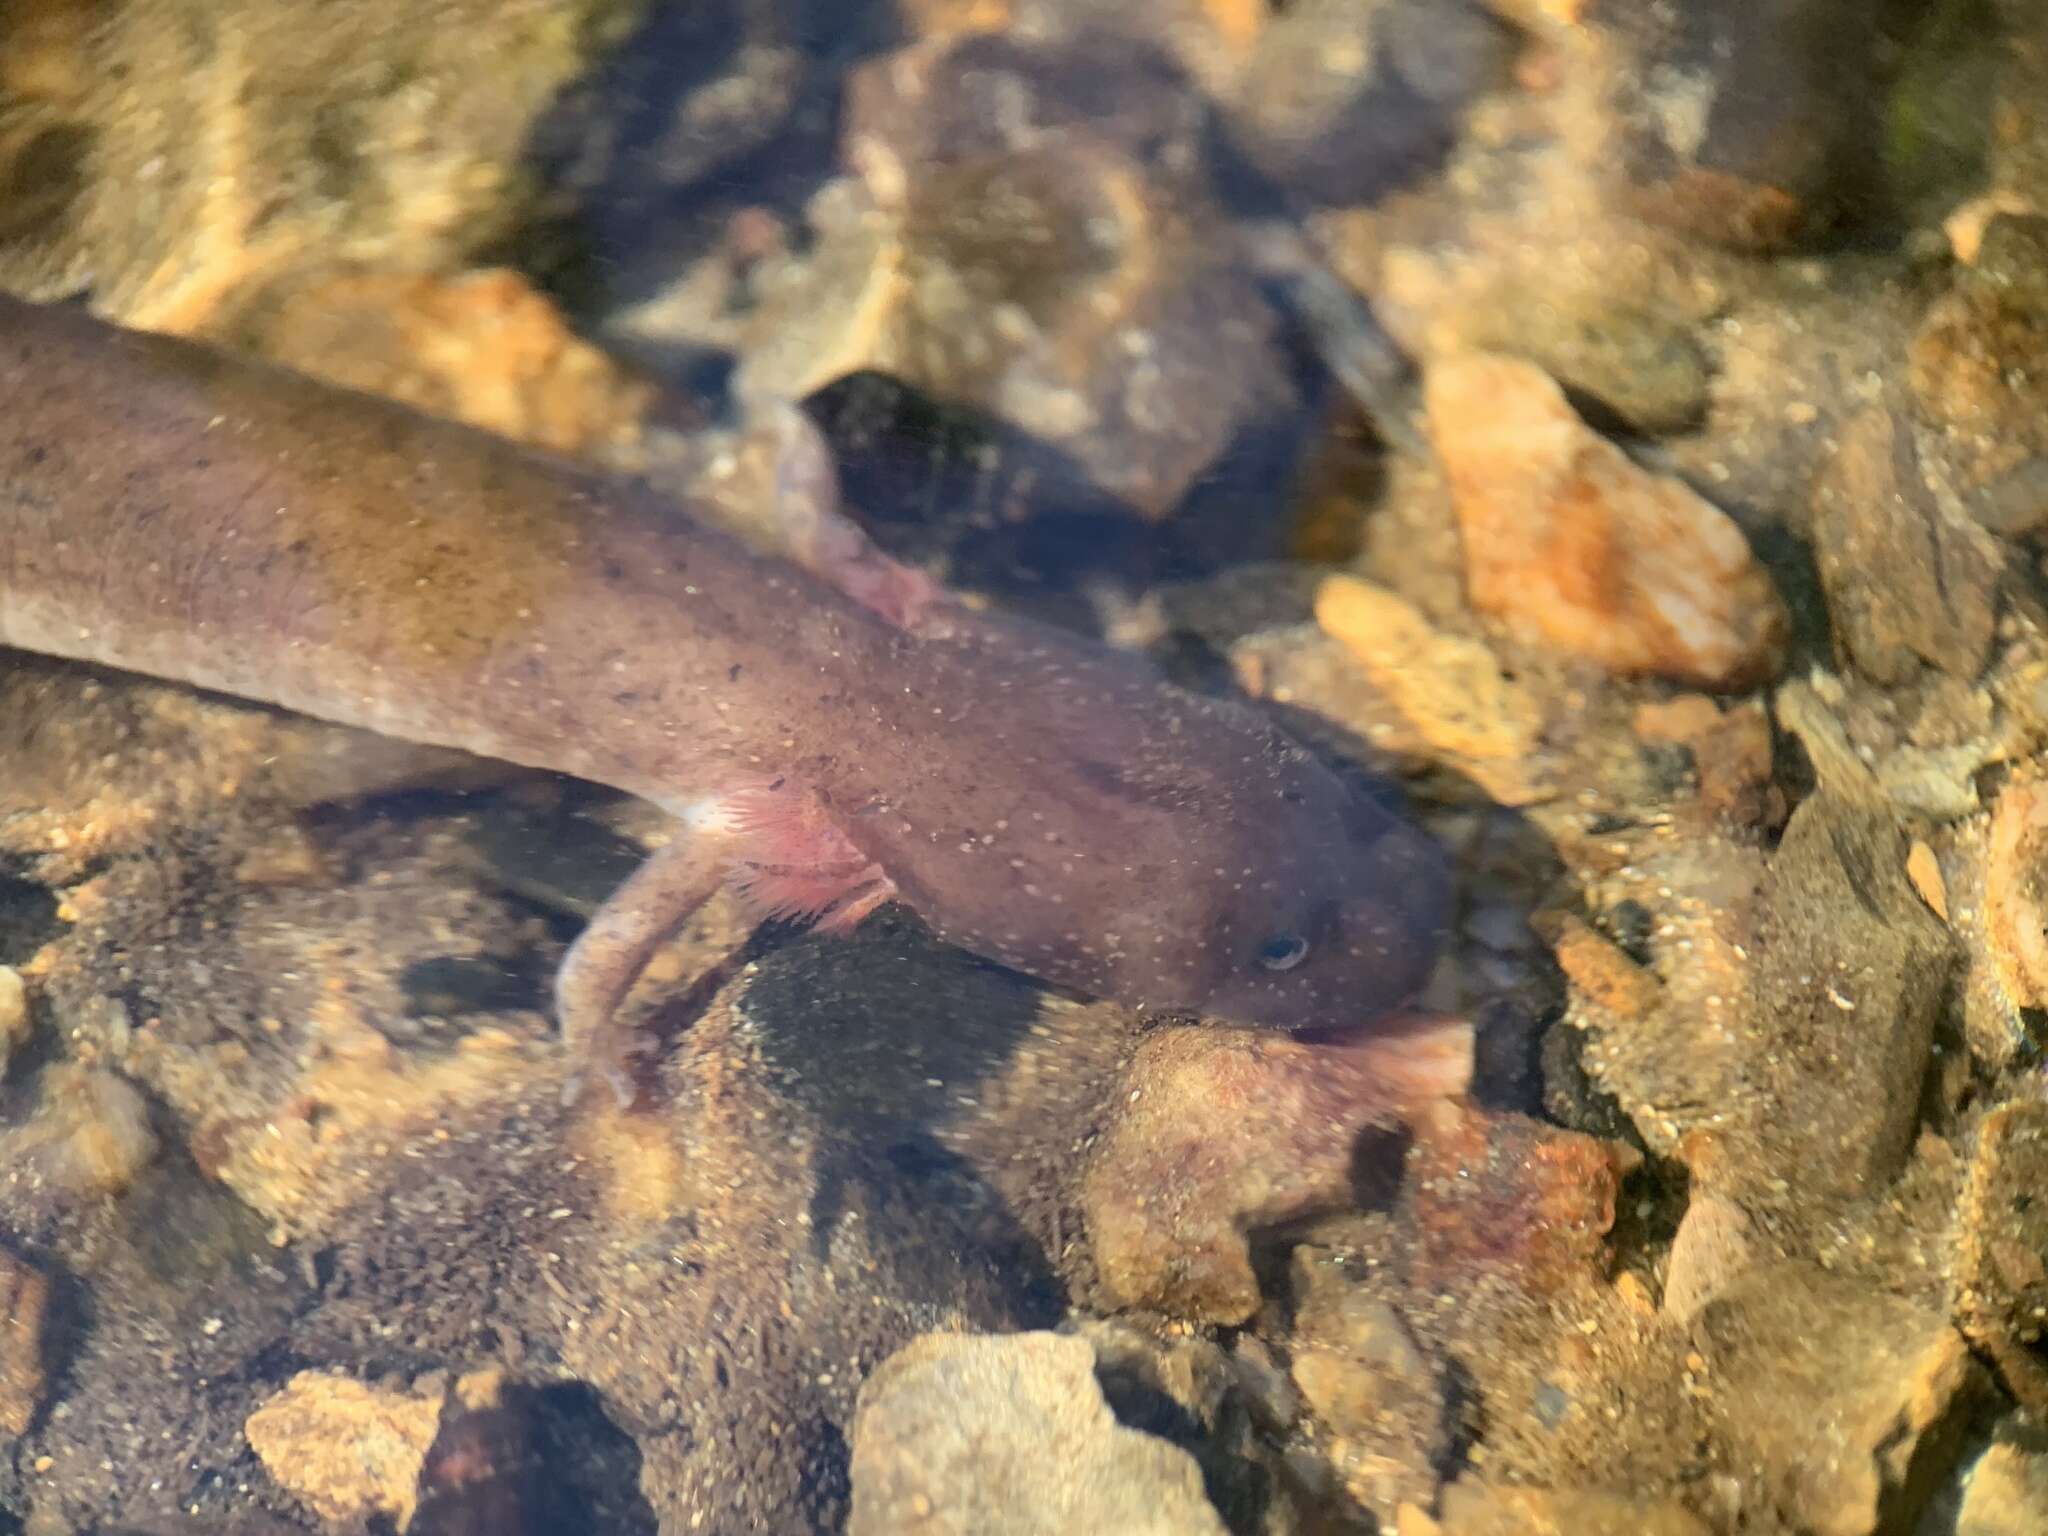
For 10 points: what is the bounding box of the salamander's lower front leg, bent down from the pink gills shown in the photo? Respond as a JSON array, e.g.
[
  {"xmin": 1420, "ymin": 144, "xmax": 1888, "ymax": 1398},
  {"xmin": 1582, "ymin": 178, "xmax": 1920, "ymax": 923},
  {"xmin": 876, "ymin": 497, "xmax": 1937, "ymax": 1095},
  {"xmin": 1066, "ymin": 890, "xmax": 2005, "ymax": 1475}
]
[{"xmin": 555, "ymin": 825, "xmax": 733, "ymax": 1104}]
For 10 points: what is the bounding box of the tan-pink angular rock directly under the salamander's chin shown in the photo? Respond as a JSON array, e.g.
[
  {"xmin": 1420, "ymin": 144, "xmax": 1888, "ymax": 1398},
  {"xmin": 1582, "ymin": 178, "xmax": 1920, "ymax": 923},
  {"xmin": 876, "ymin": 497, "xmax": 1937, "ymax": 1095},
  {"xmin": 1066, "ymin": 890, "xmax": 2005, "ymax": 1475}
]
[{"xmin": 1081, "ymin": 1024, "xmax": 1473, "ymax": 1323}]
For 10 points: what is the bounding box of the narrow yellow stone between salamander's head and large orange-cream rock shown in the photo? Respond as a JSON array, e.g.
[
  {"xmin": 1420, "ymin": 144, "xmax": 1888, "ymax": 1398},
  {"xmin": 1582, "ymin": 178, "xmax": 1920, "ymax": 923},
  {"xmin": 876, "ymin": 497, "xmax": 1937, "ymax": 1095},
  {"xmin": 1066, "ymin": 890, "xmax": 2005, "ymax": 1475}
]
[{"xmin": 1315, "ymin": 575, "xmax": 1542, "ymax": 758}]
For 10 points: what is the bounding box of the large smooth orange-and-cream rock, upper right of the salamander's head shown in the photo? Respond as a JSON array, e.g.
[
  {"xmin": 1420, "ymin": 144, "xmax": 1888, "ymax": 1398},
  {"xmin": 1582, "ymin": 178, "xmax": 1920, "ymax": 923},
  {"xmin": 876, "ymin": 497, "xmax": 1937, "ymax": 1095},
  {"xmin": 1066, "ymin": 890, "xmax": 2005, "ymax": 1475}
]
[{"xmin": 1425, "ymin": 354, "xmax": 1788, "ymax": 690}]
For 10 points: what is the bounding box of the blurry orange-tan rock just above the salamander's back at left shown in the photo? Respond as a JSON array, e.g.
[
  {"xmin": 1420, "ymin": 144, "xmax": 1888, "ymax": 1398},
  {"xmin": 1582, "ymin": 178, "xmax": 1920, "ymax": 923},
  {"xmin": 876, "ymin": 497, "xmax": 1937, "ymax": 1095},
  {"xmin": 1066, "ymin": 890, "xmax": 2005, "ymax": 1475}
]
[{"xmin": 215, "ymin": 268, "xmax": 653, "ymax": 455}]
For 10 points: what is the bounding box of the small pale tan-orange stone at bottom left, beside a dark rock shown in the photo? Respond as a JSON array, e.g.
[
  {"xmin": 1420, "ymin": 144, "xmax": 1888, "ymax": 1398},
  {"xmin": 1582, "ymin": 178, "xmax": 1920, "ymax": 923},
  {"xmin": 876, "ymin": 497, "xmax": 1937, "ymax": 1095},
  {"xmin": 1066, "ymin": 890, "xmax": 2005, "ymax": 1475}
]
[{"xmin": 242, "ymin": 1370, "xmax": 444, "ymax": 1530}]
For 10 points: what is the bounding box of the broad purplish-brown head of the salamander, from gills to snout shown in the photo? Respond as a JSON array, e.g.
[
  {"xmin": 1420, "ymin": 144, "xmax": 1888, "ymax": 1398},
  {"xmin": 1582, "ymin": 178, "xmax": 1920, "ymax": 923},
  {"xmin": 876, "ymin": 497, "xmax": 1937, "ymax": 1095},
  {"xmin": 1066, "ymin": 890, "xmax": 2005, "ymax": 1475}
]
[{"xmin": 888, "ymin": 618, "xmax": 1450, "ymax": 1030}]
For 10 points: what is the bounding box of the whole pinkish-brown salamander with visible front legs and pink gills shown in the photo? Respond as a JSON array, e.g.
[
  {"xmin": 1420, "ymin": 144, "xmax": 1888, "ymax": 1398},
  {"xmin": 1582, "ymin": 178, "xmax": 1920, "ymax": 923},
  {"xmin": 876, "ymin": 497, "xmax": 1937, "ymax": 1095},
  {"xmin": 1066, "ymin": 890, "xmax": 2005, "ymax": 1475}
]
[{"xmin": 0, "ymin": 297, "xmax": 1448, "ymax": 1097}]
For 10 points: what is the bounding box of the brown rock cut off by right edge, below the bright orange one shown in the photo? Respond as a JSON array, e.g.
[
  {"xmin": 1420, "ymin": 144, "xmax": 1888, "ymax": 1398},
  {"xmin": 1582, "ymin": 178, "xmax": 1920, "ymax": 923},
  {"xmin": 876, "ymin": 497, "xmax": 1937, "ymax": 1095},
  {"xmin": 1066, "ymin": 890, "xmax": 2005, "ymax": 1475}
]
[{"xmin": 1954, "ymin": 1100, "xmax": 2048, "ymax": 1413}]
